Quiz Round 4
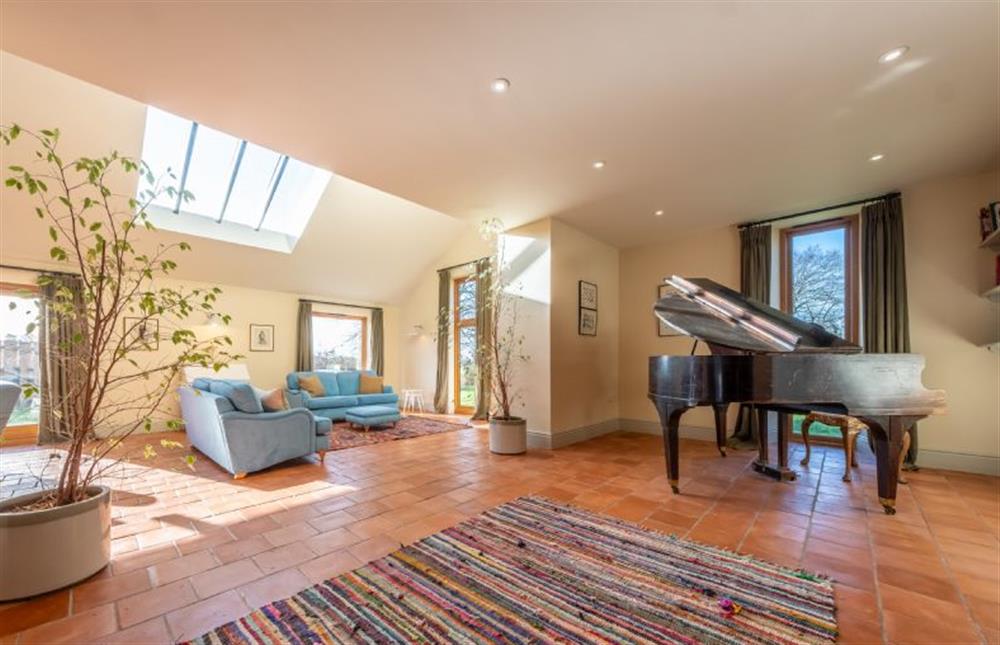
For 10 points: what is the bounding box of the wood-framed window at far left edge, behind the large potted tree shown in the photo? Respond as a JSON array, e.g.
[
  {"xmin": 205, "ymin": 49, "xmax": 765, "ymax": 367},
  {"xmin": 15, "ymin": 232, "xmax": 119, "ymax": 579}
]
[{"xmin": 0, "ymin": 283, "xmax": 40, "ymax": 443}]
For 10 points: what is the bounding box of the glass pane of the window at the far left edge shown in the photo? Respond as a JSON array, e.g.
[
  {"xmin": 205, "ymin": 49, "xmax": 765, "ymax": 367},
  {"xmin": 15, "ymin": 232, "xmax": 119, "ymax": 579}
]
[{"xmin": 0, "ymin": 293, "xmax": 39, "ymax": 426}]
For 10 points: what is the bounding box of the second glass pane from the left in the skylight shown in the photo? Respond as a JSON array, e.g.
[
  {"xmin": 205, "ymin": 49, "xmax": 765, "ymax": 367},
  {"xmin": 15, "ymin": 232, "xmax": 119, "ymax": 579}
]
[{"xmin": 181, "ymin": 125, "xmax": 240, "ymax": 219}]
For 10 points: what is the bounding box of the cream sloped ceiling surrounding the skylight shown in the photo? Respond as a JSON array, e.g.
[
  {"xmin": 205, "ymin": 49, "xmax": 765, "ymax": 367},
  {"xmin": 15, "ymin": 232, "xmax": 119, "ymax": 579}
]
[{"xmin": 0, "ymin": 53, "xmax": 469, "ymax": 304}]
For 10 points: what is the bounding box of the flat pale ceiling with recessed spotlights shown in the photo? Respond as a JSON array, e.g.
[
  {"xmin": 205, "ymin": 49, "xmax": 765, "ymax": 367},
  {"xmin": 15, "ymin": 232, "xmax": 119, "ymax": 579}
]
[{"xmin": 0, "ymin": 0, "xmax": 1000, "ymax": 246}]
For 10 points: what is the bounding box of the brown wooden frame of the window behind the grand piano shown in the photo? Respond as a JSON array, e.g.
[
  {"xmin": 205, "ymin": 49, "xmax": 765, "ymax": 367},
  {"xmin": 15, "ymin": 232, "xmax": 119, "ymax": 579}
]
[{"xmin": 780, "ymin": 214, "xmax": 861, "ymax": 343}]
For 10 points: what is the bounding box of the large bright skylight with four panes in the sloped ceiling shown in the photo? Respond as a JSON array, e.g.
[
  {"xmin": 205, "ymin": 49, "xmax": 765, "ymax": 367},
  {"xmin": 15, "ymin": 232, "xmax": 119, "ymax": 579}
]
[{"xmin": 139, "ymin": 106, "xmax": 331, "ymax": 253}]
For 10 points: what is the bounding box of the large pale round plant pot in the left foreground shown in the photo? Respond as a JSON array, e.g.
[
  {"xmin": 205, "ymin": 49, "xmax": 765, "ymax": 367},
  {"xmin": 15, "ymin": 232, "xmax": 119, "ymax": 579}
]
[{"xmin": 0, "ymin": 486, "xmax": 111, "ymax": 602}]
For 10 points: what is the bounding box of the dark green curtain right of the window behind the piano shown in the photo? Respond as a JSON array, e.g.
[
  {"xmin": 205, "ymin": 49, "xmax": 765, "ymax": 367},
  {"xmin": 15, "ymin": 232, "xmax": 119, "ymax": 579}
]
[{"xmin": 861, "ymin": 196, "xmax": 917, "ymax": 468}]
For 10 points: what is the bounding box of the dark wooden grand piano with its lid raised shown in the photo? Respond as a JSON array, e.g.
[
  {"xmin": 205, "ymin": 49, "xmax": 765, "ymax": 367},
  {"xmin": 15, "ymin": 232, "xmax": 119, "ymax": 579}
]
[{"xmin": 649, "ymin": 276, "xmax": 945, "ymax": 515}]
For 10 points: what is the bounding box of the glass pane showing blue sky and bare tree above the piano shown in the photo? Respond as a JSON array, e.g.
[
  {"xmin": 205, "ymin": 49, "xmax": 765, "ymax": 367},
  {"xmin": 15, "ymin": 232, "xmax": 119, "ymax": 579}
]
[{"xmin": 790, "ymin": 228, "xmax": 847, "ymax": 337}]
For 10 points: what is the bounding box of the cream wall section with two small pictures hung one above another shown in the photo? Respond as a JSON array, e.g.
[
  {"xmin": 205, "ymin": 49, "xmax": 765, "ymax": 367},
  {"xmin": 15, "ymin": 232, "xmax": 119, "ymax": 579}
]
[{"xmin": 551, "ymin": 219, "xmax": 619, "ymax": 435}]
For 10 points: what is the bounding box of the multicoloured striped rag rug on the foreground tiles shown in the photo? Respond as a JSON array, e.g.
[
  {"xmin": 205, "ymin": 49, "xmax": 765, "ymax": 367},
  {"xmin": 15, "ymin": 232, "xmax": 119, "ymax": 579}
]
[{"xmin": 192, "ymin": 497, "xmax": 837, "ymax": 644}]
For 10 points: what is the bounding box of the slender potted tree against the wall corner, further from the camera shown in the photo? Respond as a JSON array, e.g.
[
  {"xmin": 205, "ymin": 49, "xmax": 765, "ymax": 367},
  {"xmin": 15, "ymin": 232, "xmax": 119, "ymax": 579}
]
[{"xmin": 476, "ymin": 219, "xmax": 528, "ymax": 455}]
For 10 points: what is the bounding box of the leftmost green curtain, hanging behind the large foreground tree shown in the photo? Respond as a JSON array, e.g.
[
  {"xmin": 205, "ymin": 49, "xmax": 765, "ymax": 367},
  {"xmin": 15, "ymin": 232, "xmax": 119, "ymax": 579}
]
[{"xmin": 38, "ymin": 274, "xmax": 89, "ymax": 445}]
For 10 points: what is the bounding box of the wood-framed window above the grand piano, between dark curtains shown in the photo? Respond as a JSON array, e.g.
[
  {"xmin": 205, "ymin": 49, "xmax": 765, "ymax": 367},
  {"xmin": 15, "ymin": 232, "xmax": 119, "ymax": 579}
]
[{"xmin": 781, "ymin": 216, "xmax": 858, "ymax": 342}]
